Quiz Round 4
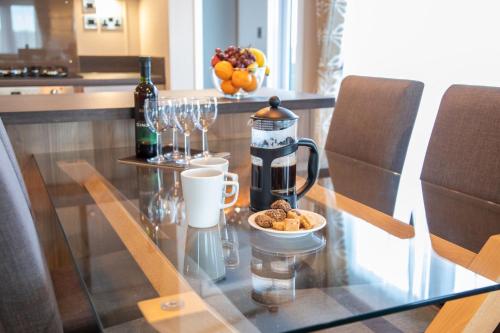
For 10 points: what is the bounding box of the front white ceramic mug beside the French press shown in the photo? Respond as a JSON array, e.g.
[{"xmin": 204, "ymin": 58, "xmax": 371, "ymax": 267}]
[{"xmin": 181, "ymin": 168, "xmax": 240, "ymax": 228}]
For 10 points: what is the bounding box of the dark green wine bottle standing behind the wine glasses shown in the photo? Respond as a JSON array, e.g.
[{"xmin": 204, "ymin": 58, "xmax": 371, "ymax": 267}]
[{"xmin": 134, "ymin": 57, "xmax": 158, "ymax": 158}]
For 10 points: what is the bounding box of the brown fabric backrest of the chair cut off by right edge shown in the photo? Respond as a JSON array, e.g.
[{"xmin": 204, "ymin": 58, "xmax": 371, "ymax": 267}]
[{"xmin": 421, "ymin": 85, "xmax": 500, "ymax": 203}]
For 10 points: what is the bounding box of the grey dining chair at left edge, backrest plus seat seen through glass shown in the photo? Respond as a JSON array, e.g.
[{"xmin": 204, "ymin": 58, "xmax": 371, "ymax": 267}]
[{"xmin": 0, "ymin": 119, "xmax": 98, "ymax": 333}]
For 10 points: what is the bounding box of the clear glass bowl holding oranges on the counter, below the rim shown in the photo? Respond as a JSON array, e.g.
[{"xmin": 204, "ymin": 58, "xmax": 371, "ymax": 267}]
[{"xmin": 212, "ymin": 67, "xmax": 266, "ymax": 99}]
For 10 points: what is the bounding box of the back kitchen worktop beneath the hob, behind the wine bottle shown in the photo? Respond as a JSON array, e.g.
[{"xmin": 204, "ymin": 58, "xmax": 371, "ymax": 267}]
[{"xmin": 0, "ymin": 72, "xmax": 165, "ymax": 87}]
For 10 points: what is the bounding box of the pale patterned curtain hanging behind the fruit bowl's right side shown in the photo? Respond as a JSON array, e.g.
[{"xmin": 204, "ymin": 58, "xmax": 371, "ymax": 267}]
[{"xmin": 313, "ymin": 0, "xmax": 347, "ymax": 147}]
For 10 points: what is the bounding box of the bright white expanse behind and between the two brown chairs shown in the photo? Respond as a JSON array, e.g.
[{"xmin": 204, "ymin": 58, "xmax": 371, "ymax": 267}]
[{"xmin": 343, "ymin": 0, "xmax": 500, "ymax": 174}]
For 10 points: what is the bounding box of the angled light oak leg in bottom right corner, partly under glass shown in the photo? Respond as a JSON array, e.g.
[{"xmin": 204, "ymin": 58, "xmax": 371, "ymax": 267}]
[{"xmin": 426, "ymin": 235, "xmax": 500, "ymax": 333}]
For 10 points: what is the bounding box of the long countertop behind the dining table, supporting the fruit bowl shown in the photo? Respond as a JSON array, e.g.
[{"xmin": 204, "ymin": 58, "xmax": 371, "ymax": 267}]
[{"xmin": 0, "ymin": 87, "xmax": 335, "ymax": 124}]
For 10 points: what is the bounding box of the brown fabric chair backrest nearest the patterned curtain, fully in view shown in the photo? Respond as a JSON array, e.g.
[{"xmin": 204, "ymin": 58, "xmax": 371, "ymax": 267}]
[{"xmin": 325, "ymin": 76, "xmax": 424, "ymax": 173}]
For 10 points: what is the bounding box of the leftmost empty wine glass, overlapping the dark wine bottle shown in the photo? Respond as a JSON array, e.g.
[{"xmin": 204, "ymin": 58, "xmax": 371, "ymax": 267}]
[{"xmin": 144, "ymin": 98, "xmax": 171, "ymax": 164}]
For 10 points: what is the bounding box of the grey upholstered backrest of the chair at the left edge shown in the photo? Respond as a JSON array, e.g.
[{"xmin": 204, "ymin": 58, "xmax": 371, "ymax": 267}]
[{"xmin": 0, "ymin": 119, "xmax": 62, "ymax": 332}]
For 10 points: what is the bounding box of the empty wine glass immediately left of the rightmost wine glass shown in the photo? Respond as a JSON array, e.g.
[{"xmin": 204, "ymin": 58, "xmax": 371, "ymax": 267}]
[{"xmin": 174, "ymin": 98, "xmax": 195, "ymax": 165}]
